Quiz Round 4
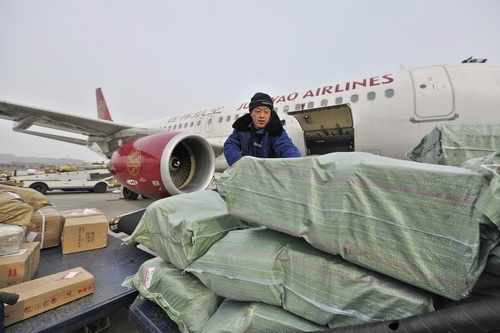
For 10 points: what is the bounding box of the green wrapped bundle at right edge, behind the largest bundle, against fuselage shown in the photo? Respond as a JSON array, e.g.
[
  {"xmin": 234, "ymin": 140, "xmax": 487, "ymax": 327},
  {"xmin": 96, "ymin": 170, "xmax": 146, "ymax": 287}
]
[{"xmin": 408, "ymin": 123, "xmax": 500, "ymax": 166}]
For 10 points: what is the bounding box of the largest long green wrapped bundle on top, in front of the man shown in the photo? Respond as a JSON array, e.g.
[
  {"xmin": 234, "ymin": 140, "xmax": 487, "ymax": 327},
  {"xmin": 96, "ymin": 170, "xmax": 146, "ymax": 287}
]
[{"xmin": 216, "ymin": 152, "xmax": 495, "ymax": 300}]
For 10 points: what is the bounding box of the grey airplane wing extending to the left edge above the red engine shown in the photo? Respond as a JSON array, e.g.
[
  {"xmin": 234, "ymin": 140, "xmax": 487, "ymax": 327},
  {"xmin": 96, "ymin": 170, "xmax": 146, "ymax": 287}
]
[{"xmin": 0, "ymin": 101, "xmax": 133, "ymax": 137}]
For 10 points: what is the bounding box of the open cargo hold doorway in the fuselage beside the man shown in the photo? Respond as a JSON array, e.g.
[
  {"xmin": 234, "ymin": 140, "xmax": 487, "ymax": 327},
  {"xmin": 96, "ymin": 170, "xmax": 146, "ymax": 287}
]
[{"xmin": 288, "ymin": 104, "xmax": 354, "ymax": 155}]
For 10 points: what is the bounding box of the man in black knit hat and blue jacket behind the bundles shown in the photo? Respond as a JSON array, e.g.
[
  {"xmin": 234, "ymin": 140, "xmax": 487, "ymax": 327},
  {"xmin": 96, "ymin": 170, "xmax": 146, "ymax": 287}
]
[{"xmin": 224, "ymin": 92, "xmax": 301, "ymax": 165}]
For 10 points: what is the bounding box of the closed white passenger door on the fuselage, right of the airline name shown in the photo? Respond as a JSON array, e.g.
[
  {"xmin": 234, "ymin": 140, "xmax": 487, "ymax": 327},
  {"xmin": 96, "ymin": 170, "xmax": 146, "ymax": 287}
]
[{"xmin": 410, "ymin": 66, "xmax": 458, "ymax": 122}]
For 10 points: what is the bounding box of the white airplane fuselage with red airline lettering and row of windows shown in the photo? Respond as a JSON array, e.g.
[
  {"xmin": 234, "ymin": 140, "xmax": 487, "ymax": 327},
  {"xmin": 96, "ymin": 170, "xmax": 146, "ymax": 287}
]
[{"xmin": 140, "ymin": 64, "xmax": 500, "ymax": 170}]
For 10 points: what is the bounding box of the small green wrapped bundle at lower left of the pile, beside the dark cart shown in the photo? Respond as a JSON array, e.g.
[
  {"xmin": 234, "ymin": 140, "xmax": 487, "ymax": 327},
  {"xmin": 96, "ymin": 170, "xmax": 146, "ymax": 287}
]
[{"xmin": 122, "ymin": 257, "xmax": 222, "ymax": 333}]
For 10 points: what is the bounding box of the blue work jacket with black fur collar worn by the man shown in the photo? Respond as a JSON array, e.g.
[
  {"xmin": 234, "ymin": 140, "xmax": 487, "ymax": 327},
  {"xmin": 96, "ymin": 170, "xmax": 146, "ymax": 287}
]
[{"xmin": 224, "ymin": 111, "xmax": 301, "ymax": 165}]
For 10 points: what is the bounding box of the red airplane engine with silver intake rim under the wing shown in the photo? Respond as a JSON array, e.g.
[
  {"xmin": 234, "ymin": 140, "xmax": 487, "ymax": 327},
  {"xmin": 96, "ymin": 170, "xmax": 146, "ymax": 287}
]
[{"xmin": 108, "ymin": 132, "xmax": 215, "ymax": 199}]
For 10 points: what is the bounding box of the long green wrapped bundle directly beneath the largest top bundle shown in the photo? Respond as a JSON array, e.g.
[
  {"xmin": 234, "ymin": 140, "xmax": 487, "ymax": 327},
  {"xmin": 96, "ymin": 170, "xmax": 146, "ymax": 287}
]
[{"xmin": 186, "ymin": 228, "xmax": 434, "ymax": 327}]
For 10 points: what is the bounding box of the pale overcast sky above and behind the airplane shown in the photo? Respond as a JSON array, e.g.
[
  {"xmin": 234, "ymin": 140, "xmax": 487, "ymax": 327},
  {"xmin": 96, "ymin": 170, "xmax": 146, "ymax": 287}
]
[{"xmin": 0, "ymin": 0, "xmax": 500, "ymax": 161}]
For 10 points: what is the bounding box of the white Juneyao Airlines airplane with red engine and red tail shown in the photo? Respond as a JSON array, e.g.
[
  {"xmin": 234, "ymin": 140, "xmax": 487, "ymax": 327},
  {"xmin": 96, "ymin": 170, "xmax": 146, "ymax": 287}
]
[{"xmin": 0, "ymin": 58, "xmax": 500, "ymax": 199}]
